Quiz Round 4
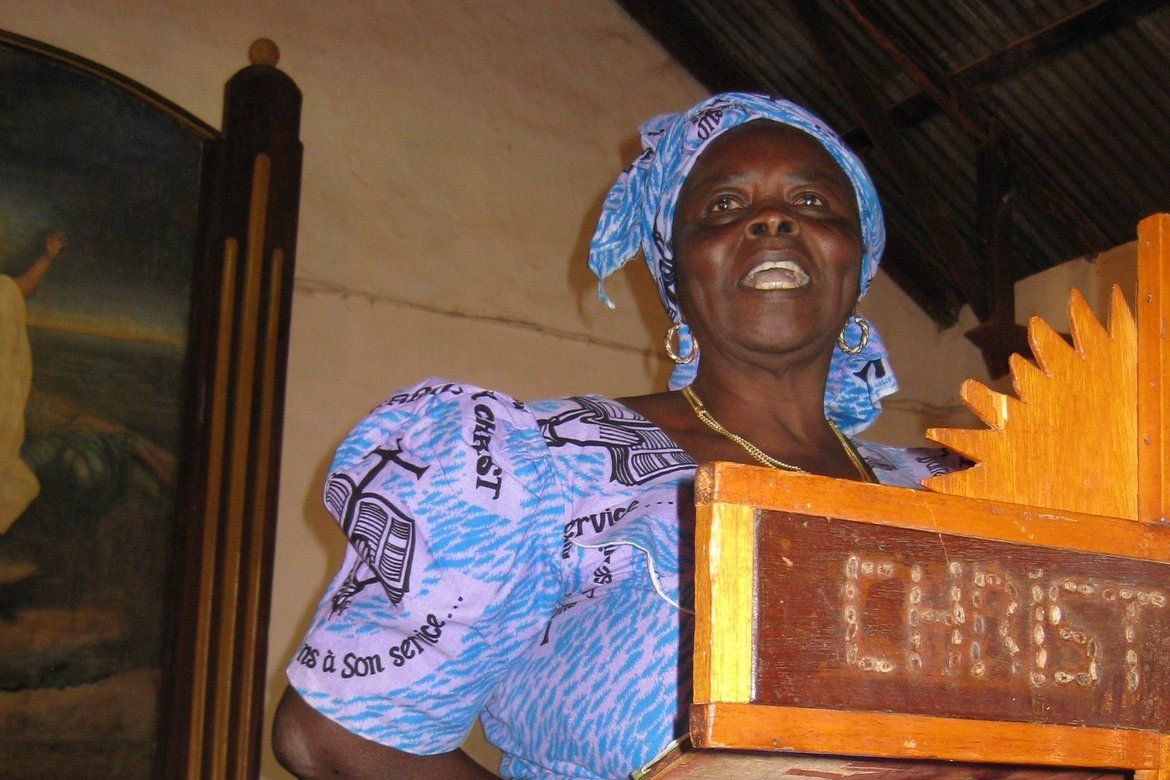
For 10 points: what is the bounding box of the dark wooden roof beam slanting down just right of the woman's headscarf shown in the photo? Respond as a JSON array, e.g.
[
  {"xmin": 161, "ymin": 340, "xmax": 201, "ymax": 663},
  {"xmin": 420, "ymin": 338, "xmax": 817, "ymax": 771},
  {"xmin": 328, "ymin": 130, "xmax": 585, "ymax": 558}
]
[{"xmin": 786, "ymin": 0, "xmax": 990, "ymax": 319}]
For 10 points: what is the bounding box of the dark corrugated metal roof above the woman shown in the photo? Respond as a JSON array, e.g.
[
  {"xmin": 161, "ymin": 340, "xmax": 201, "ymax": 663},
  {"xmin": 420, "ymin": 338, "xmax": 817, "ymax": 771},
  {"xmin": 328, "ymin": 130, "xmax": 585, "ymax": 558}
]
[{"xmin": 620, "ymin": 0, "xmax": 1170, "ymax": 322}]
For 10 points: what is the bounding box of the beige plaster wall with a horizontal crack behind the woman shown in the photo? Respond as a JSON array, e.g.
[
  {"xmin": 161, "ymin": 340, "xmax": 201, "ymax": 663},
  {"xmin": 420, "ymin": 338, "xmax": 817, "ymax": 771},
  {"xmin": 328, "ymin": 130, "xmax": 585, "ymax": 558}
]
[{"xmin": 0, "ymin": 0, "xmax": 1123, "ymax": 776}]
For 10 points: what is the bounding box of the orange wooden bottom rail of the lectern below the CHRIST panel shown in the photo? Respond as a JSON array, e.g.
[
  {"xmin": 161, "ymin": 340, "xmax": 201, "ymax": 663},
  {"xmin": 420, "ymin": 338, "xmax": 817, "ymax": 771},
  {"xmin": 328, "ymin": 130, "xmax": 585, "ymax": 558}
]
[{"xmin": 690, "ymin": 704, "xmax": 1161, "ymax": 768}]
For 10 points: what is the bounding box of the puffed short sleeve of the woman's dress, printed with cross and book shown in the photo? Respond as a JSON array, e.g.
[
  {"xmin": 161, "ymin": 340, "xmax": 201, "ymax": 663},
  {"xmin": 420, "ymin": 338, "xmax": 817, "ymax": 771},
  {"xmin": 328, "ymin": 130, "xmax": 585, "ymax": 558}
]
[{"xmin": 288, "ymin": 380, "xmax": 569, "ymax": 754}]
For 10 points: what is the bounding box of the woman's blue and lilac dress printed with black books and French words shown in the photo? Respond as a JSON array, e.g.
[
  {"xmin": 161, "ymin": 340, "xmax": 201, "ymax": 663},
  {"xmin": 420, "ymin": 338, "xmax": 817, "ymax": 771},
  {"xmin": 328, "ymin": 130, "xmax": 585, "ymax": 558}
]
[{"xmin": 288, "ymin": 379, "xmax": 943, "ymax": 778}]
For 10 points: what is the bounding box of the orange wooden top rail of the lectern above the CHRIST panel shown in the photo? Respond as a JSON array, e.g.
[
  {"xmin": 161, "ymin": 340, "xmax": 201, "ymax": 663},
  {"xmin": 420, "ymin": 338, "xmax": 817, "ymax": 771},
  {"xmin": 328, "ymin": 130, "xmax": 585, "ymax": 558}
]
[{"xmin": 695, "ymin": 463, "xmax": 1170, "ymax": 560}]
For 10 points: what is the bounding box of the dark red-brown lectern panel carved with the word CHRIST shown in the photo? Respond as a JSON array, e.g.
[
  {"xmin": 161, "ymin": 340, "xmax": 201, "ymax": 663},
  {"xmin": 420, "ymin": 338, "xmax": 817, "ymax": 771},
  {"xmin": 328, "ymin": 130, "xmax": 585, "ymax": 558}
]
[{"xmin": 752, "ymin": 511, "xmax": 1170, "ymax": 731}]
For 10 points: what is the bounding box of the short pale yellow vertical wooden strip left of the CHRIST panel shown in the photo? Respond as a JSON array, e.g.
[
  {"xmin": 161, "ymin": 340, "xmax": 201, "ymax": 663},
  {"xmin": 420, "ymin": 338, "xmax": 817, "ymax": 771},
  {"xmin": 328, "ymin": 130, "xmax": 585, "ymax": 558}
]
[{"xmin": 694, "ymin": 504, "xmax": 756, "ymax": 702}]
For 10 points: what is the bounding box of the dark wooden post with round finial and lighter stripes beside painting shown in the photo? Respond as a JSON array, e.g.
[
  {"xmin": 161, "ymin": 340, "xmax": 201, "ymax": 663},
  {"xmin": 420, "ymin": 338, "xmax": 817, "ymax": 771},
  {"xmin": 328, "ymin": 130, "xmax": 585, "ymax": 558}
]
[{"xmin": 165, "ymin": 39, "xmax": 302, "ymax": 778}]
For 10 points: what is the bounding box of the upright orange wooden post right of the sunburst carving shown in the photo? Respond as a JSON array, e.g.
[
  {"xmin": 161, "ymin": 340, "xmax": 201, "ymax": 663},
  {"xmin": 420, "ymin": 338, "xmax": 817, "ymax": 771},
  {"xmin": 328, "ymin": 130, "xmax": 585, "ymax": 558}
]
[{"xmin": 1137, "ymin": 214, "xmax": 1170, "ymax": 523}]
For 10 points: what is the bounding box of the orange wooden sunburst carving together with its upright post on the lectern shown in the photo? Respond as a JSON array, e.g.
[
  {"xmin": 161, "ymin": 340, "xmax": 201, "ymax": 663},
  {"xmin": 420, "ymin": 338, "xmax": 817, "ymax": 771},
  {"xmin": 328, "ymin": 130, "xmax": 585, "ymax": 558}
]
[{"xmin": 924, "ymin": 214, "xmax": 1170, "ymax": 530}]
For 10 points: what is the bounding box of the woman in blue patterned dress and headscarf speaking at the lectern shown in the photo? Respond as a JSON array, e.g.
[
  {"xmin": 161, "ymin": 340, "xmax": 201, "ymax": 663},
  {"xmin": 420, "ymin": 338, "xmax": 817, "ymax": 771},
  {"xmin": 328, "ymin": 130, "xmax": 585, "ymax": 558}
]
[{"xmin": 275, "ymin": 94, "xmax": 950, "ymax": 778}]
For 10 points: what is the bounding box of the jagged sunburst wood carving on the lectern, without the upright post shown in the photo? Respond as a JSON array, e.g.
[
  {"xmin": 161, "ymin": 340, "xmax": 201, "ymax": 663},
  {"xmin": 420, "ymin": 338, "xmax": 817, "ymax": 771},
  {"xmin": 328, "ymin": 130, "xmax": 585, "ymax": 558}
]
[{"xmin": 924, "ymin": 287, "xmax": 1137, "ymax": 519}]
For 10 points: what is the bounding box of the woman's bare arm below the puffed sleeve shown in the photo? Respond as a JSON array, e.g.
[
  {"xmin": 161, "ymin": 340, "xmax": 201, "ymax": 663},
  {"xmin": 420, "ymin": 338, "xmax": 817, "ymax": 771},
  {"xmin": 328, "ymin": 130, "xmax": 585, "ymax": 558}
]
[{"xmin": 273, "ymin": 686, "xmax": 495, "ymax": 780}]
